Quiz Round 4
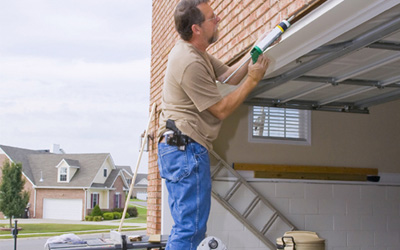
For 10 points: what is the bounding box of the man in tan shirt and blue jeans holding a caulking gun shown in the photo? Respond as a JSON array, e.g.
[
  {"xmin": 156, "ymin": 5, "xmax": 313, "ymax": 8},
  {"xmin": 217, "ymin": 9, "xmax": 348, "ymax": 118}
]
[{"xmin": 158, "ymin": 0, "xmax": 268, "ymax": 250}]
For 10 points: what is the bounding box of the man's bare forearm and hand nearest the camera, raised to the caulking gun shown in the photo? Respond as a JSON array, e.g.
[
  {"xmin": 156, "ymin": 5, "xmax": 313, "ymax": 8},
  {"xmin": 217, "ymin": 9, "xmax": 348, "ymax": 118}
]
[{"xmin": 207, "ymin": 55, "xmax": 269, "ymax": 120}]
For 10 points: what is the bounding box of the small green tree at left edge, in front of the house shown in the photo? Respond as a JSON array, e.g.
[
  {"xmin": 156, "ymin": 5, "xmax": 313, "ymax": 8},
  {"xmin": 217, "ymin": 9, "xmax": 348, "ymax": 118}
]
[{"xmin": 0, "ymin": 161, "xmax": 29, "ymax": 228}]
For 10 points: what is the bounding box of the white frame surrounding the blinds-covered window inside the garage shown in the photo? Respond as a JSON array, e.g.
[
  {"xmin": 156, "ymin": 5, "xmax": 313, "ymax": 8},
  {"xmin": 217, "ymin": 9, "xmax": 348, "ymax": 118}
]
[{"xmin": 248, "ymin": 106, "xmax": 311, "ymax": 146}]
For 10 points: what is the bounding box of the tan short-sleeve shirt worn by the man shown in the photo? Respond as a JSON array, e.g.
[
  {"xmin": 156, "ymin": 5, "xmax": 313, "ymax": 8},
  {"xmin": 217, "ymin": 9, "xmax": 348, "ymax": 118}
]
[{"xmin": 158, "ymin": 40, "xmax": 228, "ymax": 149}]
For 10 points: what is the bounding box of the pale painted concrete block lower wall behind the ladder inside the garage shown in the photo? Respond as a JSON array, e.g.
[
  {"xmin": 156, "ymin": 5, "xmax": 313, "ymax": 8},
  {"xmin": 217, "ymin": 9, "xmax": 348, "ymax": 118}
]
[{"xmin": 207, "ymin": 181, "xmax": 400, "ymax": 250}]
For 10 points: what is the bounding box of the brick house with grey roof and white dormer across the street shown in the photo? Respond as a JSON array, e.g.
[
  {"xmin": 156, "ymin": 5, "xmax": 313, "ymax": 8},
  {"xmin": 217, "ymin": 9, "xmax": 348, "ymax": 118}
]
[{"xmin": 0, "ymin": 145, "xmax": 132, "ymax": 220}]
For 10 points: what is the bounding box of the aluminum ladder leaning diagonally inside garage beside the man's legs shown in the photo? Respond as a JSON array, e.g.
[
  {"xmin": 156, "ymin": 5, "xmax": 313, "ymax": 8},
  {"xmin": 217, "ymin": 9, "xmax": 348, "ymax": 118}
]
[{"xmin": 210, "ymin": 150, "xmax": 297, "ymax": 249}]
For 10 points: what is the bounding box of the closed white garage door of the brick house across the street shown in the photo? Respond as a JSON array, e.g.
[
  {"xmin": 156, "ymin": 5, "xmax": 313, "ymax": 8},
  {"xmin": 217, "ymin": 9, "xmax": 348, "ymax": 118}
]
[{"xmin": 43, "ymin": 199, "xmax": 82, "ymax": 220}]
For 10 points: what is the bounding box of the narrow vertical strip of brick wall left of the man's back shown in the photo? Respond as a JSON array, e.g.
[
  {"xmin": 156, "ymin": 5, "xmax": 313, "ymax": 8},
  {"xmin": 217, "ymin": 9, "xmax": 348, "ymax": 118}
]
[{"xmin": 147, "ymin": 0, "xmax": 178, "ymax": 235}]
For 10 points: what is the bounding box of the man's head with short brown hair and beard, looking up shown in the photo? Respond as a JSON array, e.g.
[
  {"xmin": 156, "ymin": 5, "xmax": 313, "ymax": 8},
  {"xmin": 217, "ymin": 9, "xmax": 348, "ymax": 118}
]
[{"xmin": 174, "ymin": 0, "xmax": 220, "ymax": 44}]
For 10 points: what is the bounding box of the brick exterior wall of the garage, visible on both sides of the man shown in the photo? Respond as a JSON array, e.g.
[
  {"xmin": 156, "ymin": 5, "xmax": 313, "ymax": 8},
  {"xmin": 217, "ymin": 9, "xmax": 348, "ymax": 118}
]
[{"xmin": 147, "ymin": 0, "xmax": 318, "ymax": 234}]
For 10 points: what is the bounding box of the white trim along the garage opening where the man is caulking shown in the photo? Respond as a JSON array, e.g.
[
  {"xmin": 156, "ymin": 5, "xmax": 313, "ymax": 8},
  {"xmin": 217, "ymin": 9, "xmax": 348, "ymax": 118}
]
[{"xmin": 266, "ymin": 0, "xmax": 399, "ymax": 75}]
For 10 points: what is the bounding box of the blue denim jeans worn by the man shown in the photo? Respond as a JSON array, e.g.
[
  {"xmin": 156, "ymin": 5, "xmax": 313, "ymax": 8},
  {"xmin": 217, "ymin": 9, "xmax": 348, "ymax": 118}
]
[{"xmin": 158, "ymin": 142, "xmax": 211, "ymax": 250}]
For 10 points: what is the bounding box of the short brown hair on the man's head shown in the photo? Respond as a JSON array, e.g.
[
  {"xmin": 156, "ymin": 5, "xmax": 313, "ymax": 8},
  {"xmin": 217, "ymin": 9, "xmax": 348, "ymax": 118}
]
[{"xmin": 174, "ymin": 0, "xmax": 209, "ymax": 41}]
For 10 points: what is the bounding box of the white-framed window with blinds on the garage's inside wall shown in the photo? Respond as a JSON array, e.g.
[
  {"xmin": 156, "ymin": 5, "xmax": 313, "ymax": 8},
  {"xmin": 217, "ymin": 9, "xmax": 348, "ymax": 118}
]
[{"xmin": 249, "ymin": 106, "xmax": 311, "ymax": 145}]
